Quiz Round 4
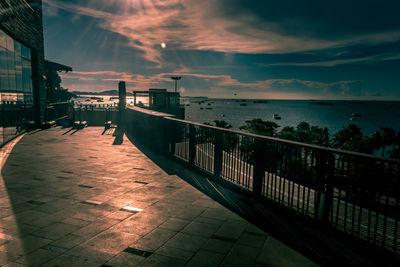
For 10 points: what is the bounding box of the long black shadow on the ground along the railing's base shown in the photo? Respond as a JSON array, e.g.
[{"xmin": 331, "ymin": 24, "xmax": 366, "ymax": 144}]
[{"xmin": 126, "ymin": 132, "xmax": 396, "ymax": 266}]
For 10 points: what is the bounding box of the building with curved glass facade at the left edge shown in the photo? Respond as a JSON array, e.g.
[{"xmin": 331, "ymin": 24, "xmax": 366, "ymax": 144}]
[{"xmin": 0, "ymin": 0, "xmax": 46, "ymax": 146}]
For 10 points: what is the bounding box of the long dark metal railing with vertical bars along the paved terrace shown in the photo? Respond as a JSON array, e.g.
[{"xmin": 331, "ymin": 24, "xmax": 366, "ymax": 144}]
[{"xmin": 126, "ymin": 107, "xmax": 400, "ymax": 255}]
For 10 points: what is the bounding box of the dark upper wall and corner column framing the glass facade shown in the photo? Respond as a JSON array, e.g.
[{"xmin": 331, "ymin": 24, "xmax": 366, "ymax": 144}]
[{"xmin": 0, "ymin": 0, "xmax": 46, "ymax": 122}]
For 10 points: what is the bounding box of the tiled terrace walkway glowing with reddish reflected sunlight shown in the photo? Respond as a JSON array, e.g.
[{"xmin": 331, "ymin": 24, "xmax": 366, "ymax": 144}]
[{"xmin": 0, "ymin": 128, "xmax": 315, "ymax": 267}]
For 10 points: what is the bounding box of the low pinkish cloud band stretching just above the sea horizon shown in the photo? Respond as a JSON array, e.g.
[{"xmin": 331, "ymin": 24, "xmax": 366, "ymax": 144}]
[{"xmin": 62, "ymin": 69, "xmax": 373, "ymax": 99}]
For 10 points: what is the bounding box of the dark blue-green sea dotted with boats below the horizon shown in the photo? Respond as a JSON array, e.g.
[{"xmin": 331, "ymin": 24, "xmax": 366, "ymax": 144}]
[{"xmin": 75, "ymin": 96, "xmax": 400, "ymax": 135}]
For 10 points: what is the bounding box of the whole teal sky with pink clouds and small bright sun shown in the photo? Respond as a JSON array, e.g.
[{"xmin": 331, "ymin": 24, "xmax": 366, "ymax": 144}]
[{"xmin": 43, "ymin": 0, "xmax": 400, "ymax": 100}]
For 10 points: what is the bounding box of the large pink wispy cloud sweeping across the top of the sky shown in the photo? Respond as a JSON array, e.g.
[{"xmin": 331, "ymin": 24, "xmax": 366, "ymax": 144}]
[{"xmin": 44, "ymin": 0, "xmax": 400, "ymax": 66}]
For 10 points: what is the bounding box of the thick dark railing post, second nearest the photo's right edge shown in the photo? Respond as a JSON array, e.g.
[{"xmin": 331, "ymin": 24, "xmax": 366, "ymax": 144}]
[{"xmin": 253, "ymin": 138, "xmax": 266, "ymax": 195}]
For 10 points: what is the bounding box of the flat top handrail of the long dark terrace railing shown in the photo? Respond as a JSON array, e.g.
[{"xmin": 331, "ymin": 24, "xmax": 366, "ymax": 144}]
[{"xmin": 165, "ymin": 117, "xmax": 400, "ymax": 164}]
